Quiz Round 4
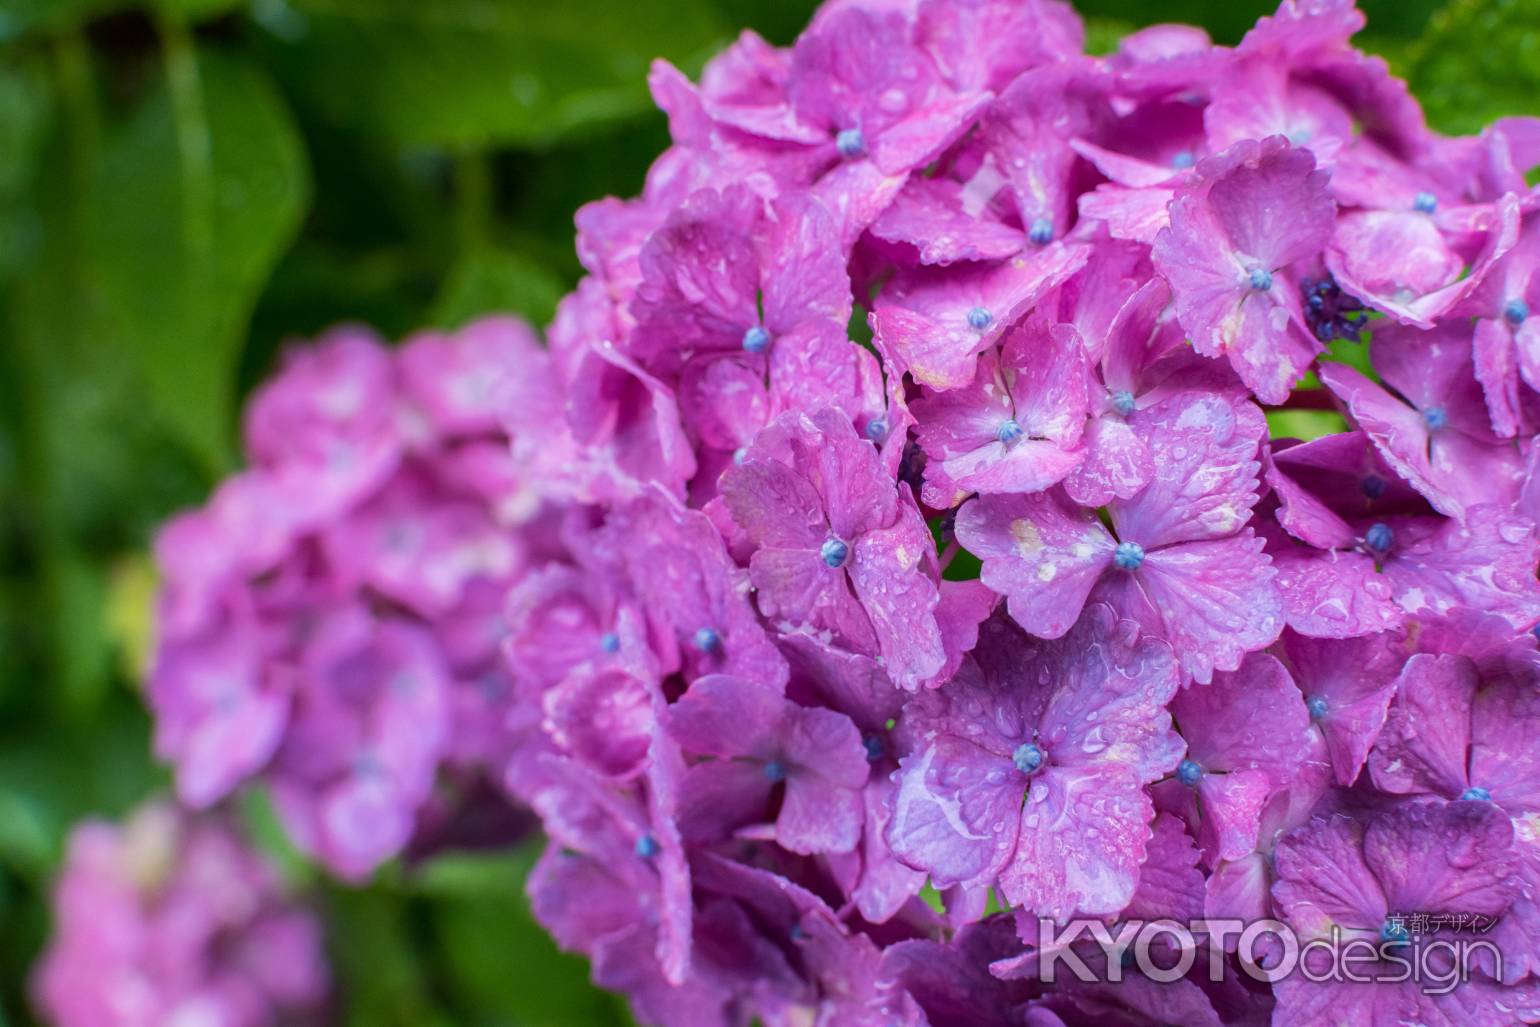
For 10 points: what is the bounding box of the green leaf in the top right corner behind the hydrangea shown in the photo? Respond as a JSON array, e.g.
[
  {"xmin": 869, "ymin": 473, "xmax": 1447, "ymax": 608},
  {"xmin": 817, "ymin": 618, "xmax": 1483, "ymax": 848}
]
[{"xmin": 1406, "ymin": 0, "xmax": 1540, "ymax": 134}]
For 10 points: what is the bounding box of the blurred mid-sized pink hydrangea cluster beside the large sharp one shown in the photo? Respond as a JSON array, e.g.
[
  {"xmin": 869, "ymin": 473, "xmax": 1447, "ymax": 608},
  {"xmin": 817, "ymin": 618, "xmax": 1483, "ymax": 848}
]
[{"xmin": 146, "ymin": 319, "xmax": 539, "ymax": 878}]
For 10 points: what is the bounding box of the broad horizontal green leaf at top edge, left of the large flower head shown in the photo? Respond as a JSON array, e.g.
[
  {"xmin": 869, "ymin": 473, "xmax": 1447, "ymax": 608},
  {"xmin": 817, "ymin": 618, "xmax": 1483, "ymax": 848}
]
[{"xmin": 254, "ymin": 0, "xmax": 728, "ymax": 148}]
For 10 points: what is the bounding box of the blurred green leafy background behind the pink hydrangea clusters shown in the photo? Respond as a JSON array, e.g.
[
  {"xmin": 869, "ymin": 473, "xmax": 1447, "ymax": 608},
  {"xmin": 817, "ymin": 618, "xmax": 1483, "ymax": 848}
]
[{"xmin": 0, "ymin": 0, "xmax": 1540, "ymax": 1027}]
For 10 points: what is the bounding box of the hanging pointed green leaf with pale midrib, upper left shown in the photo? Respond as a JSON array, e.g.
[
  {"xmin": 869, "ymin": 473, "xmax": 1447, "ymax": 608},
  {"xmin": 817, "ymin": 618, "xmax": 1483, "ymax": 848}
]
[{"xmin": 86, "ymin": 44, "xmax": 310, "ymax": 470}]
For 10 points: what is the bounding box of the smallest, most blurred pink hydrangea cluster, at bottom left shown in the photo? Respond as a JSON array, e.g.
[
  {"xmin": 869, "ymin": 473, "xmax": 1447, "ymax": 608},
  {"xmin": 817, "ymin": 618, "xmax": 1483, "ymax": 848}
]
[{"xmin": 34, "ymin": 802, "xmax": 328, "ymax": 1027}]
